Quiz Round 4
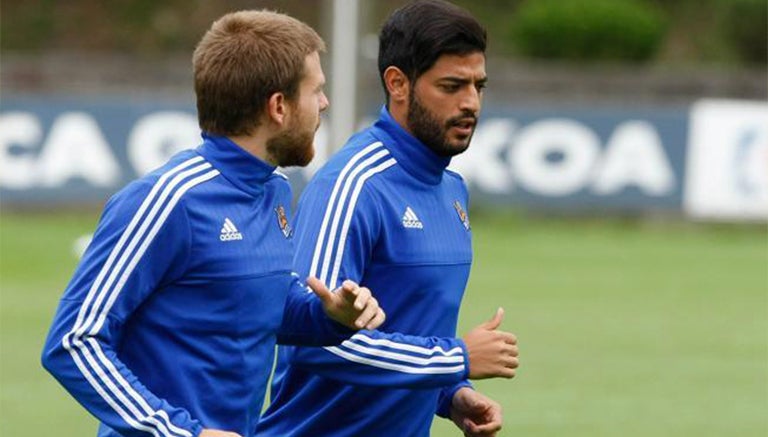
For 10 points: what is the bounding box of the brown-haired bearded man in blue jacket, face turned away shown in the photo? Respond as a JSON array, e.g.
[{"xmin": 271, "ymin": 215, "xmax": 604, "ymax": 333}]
[{"xmin": 42, "ymin": 11, "xmax": 384, "ymax": 437}]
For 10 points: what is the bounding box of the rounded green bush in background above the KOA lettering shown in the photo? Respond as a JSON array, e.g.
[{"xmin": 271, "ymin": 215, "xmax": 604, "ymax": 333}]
[{"xmin": 510, "ymin": 0, "xmax": 666, "ymax": 61}]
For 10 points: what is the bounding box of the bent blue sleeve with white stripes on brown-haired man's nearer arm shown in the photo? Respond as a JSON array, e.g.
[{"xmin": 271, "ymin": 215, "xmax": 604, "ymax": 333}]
[{"xmin": 42, "ymin": 183, "xmax": 202, "ymax": 437}]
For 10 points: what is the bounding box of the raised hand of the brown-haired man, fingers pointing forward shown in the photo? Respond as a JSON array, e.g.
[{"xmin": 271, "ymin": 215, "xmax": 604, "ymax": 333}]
[{"xmin": 307, "ymin": 277, "xmax": 386, "ymax": 330}]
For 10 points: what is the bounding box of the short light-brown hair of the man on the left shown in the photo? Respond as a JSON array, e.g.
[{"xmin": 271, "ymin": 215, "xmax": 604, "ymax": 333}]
[{"xmin": 192, "ymin": 10, "xmax": 325, "ymax": 136}]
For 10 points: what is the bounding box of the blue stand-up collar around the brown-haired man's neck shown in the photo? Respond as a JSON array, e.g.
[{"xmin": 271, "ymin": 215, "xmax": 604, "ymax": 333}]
[{"xmin": 197, "ymin": 132, "xmax": 277, "ymax": 195}]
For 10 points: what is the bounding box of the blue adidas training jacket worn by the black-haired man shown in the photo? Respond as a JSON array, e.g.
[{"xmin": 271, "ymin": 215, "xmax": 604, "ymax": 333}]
[{"xmin": 258, "ymin": 108, "xmax": 472, "ymax": 437}]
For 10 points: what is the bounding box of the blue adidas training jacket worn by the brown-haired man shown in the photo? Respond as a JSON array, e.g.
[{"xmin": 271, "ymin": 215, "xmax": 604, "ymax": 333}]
[{"xmin": 42, "ymin": 134, "xmax": 350, "ymax": 437}]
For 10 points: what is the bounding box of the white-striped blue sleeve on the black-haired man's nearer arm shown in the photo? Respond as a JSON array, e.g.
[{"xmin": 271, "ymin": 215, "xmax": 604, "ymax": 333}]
[{"xmin": 281, "ymin": 178, "xmax": 469, "ymax": 388}]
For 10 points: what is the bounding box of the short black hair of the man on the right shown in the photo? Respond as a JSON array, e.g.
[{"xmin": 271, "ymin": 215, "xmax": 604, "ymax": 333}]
[{"xmin": 379, "ymin": 0, "xmax": 487, "ymax": 100}]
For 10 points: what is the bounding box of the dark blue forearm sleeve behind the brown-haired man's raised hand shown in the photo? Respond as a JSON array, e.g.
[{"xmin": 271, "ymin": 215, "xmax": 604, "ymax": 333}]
[{"xmin": 277, "ymin": 278, "xmax": 355, "ymax": 346}]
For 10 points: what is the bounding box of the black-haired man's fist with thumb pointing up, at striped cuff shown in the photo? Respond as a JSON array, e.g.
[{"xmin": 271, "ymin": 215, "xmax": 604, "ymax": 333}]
[{"xmin": 464, "ymin": 308, "xmax": 520, "ymax": 379}]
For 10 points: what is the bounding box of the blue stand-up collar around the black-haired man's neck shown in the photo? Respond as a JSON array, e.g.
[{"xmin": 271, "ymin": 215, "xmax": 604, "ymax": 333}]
[{"xmin": 373, "ymin": 106, "xmax": 451, "ymax": 185}]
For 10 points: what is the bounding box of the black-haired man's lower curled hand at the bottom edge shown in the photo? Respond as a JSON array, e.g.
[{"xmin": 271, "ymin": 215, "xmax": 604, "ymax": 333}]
[{"xmin": 451, "ymin": 387, "xmax": 502, "ymax": 437}]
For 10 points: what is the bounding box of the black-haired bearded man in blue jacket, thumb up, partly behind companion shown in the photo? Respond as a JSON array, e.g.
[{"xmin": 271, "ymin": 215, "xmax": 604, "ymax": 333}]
[{"xmin": 258, "ymin": 0, "xmax": 518, "ymax": 437}]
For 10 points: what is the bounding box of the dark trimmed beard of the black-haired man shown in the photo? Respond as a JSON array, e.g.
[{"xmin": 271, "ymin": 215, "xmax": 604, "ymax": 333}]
[{"xmin": 406, "ymin": 88, "xmax": 477, "ymax": 157}]
